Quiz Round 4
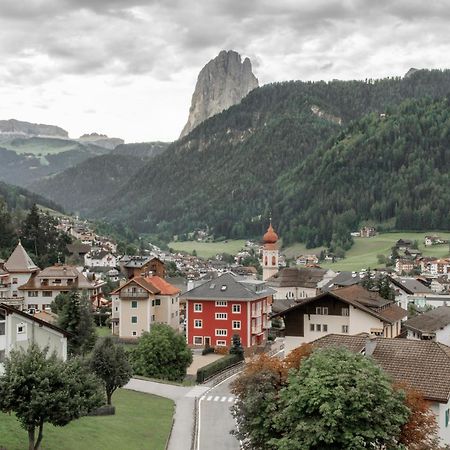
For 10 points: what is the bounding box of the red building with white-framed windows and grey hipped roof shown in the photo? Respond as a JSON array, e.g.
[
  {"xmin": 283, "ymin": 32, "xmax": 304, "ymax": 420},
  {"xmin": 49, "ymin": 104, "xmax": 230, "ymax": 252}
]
[{"xmin": 182, "ymin": 273, "xmax": 275, "ymax": 348}]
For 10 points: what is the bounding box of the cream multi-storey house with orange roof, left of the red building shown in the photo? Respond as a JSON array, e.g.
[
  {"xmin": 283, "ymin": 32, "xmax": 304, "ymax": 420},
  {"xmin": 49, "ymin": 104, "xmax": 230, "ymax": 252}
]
[{"xmin": 111, "ymin": 275, "xmax": 180, "ymax": 339}]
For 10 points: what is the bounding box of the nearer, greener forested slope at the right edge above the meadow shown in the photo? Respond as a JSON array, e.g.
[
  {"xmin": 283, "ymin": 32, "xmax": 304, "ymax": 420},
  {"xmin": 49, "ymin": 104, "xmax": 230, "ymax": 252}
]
[{"xmin": 274, "ymin": 97, "xmax": 450, "ymax": 246}]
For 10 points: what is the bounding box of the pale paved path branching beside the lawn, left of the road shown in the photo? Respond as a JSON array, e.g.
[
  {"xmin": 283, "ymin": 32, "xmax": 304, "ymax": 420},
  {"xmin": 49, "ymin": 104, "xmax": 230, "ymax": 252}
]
[{"xmin": 125, "ymin": 378, "xmax": 209, "ymax": 450}]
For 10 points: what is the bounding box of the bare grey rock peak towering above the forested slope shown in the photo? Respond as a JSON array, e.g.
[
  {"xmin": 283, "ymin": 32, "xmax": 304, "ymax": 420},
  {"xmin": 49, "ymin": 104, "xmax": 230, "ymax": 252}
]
[{"xmin": 180, "ymin": 50, "xmax": 258, "ymax": 137}]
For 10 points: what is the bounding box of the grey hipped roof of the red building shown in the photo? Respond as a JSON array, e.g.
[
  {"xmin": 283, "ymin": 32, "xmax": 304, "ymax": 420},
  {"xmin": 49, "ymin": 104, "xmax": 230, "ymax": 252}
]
[{"xmin": 181, "ymin": 273, "xmax": 275, "ymax": 300}]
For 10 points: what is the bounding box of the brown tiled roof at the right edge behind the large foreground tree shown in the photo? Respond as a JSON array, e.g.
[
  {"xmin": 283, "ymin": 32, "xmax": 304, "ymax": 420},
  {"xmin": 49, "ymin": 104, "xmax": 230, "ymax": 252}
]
[{"xmin": 313, "ymin": 334, "xmax": 450, "ymax": 403}]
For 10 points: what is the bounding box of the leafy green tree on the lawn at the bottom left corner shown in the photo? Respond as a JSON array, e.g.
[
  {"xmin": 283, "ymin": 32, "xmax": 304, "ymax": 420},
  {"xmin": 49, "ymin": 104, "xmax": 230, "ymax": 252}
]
[{"xmin": 0, "ymin": 344, "xmax": 103, "ymax": 450}]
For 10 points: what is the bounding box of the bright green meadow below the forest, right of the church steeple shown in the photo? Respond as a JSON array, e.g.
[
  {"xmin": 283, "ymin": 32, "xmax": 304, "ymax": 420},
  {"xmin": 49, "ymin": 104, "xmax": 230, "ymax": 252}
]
[{"xmin": 282, "ymin": 231, "xmax": 450, "ymax": 271}]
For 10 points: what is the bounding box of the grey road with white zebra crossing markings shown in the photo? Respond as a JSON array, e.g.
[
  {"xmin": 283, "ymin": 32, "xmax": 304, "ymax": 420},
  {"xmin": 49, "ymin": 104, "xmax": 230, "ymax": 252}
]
[{"xmin": 196, "ymin": 375, "xmax": 240, "ymax": 450}]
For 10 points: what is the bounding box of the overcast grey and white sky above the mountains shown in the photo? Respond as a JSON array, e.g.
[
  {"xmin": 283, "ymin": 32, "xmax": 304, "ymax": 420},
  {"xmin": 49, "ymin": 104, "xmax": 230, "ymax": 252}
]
[{"xmin": 0, "ymin": 0, "xmax": 450, "ymax": 142}]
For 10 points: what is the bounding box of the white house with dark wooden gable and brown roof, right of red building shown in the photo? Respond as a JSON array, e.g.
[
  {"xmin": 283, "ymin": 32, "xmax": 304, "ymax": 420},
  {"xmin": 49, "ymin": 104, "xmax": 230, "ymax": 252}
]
[{"xmin": 274, "ymin": 285, "xmax": 408, "ymax": 352}]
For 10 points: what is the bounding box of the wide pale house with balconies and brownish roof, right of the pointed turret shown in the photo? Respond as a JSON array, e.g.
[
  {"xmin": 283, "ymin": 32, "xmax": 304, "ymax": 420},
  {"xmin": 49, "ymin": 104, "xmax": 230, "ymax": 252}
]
[{"xmin": 18, "ymin": 264, "xmax": 105, "ymax": 310}]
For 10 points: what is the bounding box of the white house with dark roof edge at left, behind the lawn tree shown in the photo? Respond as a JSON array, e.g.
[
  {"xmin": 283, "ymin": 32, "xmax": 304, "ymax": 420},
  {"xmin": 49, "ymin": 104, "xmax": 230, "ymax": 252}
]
[{"xmin": 0, "ymin": 303, "xmax": 68, "ymax": 374}]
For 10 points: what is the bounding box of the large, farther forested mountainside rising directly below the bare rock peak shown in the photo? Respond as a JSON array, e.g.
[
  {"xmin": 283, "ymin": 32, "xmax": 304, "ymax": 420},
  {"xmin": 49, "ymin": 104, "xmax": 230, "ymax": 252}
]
[{"xmin": 88, "ymin": 71, "xmax": 450, "ymax": 242}]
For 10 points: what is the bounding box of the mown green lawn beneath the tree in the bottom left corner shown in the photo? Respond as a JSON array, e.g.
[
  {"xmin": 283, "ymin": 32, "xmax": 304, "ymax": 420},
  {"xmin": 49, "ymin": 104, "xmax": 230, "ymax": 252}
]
[{"xmin": 0, "ymin": 389, "xmax": 174, "ymax": 450}]
